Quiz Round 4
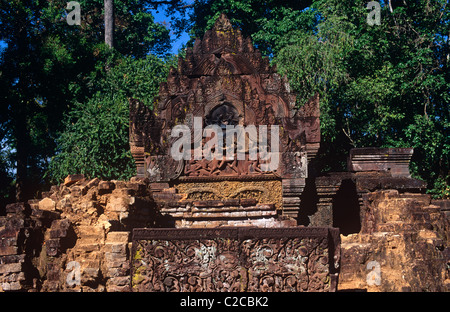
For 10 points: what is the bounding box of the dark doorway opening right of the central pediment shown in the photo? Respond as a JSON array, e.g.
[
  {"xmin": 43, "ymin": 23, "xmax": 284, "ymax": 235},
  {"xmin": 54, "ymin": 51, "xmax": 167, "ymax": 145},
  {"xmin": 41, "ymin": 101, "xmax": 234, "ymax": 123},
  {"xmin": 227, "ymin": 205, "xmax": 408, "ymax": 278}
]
[{"xmin": 333, "ymin": 179, "xmax": 361, "ymax": 235}]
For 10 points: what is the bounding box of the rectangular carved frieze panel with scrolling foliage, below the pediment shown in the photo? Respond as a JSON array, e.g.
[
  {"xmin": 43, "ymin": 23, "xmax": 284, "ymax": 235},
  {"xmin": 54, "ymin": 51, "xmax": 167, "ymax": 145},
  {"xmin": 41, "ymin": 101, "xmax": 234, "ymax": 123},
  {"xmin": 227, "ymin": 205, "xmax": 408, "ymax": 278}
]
[{"xmin": 132, "ymin": 228, "xmax": 339, "ymax": 292}]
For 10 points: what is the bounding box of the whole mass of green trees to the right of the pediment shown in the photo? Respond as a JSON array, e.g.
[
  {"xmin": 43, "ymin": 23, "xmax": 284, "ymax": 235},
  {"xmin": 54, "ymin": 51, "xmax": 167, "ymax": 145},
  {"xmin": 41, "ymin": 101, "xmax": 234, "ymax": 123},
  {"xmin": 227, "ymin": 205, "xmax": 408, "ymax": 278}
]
[{"xmin": 192, "ymin": 0, "xmax": 450, "ymax": 197}]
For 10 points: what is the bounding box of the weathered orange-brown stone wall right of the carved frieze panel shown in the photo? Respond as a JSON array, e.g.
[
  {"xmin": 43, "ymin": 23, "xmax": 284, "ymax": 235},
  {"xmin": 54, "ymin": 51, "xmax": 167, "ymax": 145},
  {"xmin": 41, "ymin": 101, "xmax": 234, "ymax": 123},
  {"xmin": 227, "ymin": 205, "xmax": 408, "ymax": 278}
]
[{"xmin": 338, "ymin": 190, "xmax": 450, "ymax": 292}]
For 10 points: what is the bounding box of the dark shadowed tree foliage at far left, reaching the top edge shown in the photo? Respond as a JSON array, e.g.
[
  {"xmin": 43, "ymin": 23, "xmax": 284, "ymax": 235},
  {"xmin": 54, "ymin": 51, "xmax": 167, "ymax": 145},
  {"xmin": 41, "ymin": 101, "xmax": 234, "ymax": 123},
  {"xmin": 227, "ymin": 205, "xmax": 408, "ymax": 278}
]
[{"xmin": 0, "ymin": 0, "xmax": 171, "ymax": 200}]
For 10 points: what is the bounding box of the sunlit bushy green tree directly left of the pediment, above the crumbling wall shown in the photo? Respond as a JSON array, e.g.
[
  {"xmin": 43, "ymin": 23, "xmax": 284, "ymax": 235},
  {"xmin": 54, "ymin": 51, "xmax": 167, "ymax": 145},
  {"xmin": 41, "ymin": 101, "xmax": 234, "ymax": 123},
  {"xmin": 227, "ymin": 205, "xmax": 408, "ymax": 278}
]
[{"xmin": 48, "ymin": 56, "xmax": 173, "ymax": 182}]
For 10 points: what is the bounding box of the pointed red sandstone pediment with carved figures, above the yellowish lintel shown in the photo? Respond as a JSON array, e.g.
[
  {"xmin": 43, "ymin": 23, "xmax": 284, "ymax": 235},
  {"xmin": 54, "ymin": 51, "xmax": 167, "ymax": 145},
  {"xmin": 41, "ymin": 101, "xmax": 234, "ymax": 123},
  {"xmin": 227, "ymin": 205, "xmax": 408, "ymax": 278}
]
[{"xmin": 130, "ymin": 15, "xmax": 320, "ymax": 219}]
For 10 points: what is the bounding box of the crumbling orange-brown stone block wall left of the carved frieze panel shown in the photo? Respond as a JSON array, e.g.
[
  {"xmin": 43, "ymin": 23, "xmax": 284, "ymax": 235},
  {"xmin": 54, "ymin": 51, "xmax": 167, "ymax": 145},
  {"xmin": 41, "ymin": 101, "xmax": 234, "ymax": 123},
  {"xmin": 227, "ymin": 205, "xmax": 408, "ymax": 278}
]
[{"xmin": 0, "ymin": 175, "xmax": 157, "ymax": 291}]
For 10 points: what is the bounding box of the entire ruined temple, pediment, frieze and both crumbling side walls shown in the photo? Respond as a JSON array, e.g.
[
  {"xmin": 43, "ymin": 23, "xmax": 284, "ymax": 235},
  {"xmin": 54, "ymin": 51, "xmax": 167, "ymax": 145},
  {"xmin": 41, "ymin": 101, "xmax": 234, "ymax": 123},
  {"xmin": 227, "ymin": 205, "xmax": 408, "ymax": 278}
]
[{"xmin": 0, "ymin": 16, "xmax": 450, "ymax": 292}]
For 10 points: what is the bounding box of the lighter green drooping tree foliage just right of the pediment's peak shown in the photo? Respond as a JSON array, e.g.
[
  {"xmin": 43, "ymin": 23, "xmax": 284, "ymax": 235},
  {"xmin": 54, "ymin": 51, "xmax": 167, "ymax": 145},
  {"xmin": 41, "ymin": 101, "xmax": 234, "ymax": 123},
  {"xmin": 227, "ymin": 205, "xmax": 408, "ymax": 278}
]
[{"xmin": 273, "ymin": 13, "xmax": 354, "ymax": 141}]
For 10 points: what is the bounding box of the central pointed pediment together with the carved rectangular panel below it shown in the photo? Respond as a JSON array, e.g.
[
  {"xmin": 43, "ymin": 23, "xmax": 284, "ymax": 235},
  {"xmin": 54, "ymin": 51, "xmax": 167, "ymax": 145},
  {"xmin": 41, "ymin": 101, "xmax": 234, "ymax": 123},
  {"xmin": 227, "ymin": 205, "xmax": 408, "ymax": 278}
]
[{"xmin": 125, "ymin": 15, "xmax": 339, "ymax": 291}]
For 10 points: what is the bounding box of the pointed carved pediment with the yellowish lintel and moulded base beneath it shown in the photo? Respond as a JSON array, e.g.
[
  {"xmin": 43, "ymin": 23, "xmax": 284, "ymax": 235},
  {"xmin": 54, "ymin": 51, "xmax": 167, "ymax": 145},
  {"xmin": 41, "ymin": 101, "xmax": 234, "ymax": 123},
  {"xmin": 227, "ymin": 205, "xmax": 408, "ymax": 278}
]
[{"xmin": 130, "ymin": 15, "xmax": 320, "ymax": 227}]
